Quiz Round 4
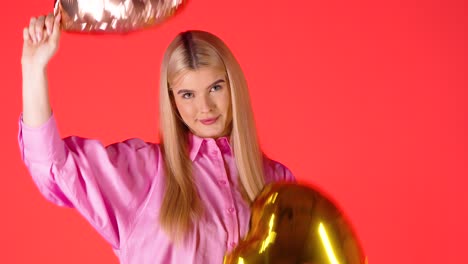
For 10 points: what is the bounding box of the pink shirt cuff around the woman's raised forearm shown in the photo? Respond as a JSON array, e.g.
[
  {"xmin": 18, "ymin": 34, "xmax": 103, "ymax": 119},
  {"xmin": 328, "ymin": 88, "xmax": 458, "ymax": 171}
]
[{"xmin": 18, "ymin": 113, "xmax": 65, "ymax": 162}]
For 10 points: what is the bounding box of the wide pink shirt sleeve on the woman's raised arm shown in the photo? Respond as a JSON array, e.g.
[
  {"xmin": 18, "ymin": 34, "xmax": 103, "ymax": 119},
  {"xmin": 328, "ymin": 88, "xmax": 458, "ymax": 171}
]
[{"xmin": 18, "ymin": 112, "xmax": 159, "ymax": 249}]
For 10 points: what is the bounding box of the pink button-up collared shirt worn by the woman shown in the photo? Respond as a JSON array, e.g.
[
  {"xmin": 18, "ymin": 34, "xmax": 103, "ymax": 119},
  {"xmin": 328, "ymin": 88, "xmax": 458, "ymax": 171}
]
[{"xmin": 18, "ymin": 116, "xmax": 294, "ymax": 264}]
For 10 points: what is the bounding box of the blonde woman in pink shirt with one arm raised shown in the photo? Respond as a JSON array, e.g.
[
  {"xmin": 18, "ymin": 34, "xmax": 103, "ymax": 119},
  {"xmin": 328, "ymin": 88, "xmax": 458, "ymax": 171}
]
[{"xmin": 18, "ymin": 12, "xmax": 294, "ymax": 264}]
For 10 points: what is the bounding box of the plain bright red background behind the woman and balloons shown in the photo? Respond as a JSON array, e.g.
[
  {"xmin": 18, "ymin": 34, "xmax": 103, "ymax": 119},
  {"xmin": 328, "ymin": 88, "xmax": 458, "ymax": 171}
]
[{"xmin": 0, "ymin": 0, "xmax": 468, "ymax": 264}]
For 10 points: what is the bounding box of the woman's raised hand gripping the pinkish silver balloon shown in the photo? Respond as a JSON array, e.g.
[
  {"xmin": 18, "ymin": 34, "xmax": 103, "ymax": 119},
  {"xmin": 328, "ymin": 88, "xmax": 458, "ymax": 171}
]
[{"xmin": 21, "ymin": 13, "xmax": 61, "ymax": 68}]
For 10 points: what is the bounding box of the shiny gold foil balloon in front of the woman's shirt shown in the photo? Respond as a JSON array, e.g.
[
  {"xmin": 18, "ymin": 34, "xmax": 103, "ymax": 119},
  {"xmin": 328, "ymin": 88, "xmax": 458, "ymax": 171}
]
[{"xmin": 224, "ymin": 183, "xmax": 367, "ymax": 264}]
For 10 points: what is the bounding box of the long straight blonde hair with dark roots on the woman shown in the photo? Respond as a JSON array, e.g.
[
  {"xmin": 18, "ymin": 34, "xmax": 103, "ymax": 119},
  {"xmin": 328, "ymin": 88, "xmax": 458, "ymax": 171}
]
[{"xmin": 159, "ymin": 31, "xmax": 265, "ymax": 241}]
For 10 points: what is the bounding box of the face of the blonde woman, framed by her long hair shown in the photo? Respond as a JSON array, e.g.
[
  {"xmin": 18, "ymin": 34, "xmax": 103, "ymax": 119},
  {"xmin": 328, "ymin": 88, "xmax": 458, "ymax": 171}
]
[{"xmin": 172, "ymin": 67, "xmax": 232, "ymax": 138}]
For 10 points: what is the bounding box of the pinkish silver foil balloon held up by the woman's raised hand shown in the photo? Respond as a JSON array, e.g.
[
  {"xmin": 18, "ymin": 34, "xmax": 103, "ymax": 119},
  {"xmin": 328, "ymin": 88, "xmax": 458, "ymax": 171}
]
[{"xmin": 54, "ymin": 0, "xmax": 185, "ymax": 33}]
